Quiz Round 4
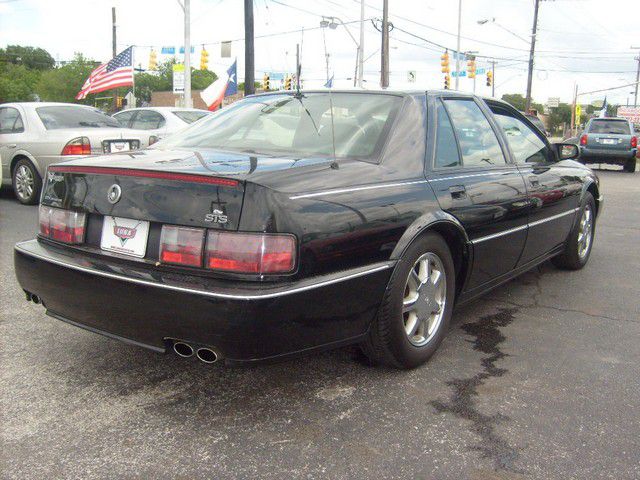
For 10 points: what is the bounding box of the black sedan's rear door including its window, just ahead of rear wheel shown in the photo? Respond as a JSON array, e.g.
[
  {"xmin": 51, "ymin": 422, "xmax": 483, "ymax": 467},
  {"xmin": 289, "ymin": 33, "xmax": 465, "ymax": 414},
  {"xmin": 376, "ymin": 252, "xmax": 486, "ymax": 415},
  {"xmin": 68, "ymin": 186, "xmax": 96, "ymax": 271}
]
[{"xmin": 428, "ymin": 96, "xmax": 527, "ymax": 291}]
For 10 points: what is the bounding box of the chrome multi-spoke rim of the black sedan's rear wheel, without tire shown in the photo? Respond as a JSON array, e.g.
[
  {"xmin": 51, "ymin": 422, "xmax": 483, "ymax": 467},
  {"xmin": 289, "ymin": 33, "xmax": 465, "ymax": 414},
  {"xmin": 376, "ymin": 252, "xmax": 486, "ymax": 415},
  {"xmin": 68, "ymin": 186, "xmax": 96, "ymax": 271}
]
[{"xmin": 402, "ymin": 252, "xmax": 447, "ymax": 347}]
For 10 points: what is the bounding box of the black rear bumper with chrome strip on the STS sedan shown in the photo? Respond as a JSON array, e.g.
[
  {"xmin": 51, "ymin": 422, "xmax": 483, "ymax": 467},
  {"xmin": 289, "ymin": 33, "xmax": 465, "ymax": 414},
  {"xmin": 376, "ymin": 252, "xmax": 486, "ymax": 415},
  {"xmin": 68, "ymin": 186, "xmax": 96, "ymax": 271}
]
[{"xmin": 14, "ymin": 240, "xmax": 393, "ymax": 362}]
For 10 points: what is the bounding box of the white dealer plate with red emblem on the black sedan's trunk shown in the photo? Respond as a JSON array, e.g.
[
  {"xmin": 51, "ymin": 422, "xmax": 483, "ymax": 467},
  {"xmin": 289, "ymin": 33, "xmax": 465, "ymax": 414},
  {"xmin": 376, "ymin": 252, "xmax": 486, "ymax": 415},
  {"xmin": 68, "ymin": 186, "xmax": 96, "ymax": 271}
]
[{"xmin": 100, "ymin": 216, "xmax": 149, "ymax": 258}]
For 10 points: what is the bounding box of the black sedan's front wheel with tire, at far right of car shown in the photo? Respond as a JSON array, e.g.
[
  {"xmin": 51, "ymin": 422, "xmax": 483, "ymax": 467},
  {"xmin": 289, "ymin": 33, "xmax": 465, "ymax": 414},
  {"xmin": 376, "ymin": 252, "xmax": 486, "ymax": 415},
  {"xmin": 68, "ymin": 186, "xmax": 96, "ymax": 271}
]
[{"xmin": 551, "ymin": 192, "xmax": 596, "ymax": 270}]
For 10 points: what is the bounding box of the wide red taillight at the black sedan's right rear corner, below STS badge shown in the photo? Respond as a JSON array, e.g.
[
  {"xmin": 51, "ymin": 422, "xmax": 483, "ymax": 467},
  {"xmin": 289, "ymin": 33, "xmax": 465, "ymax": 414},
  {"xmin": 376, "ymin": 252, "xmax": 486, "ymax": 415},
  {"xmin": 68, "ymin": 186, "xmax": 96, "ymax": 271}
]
[{"xmin": 205, "ymin": 230, "xmax": 296, "ymax": 274}]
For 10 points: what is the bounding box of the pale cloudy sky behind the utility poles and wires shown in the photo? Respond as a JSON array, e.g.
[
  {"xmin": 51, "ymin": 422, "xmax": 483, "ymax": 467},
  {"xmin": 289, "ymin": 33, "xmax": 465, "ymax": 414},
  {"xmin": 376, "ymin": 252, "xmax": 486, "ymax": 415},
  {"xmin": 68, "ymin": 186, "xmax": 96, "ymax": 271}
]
[{"xmin": 0, "ymin": 0, "xmax": 640, "ymax": 105}]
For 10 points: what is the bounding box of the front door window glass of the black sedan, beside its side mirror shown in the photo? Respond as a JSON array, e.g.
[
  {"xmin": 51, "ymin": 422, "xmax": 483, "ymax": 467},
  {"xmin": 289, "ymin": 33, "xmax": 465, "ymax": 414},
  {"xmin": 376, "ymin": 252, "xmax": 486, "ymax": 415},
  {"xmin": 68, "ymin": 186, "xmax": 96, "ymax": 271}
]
[{"xmin": 491, "ymin": 106, "xmax": 553, "ymax": 164}]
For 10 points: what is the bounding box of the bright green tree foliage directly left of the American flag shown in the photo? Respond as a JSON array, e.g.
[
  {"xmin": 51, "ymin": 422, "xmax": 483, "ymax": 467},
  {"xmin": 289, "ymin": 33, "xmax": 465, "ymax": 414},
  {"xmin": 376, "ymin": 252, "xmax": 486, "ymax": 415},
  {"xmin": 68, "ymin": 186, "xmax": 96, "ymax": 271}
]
[{"xmin": 36, "ymin": 53, "xmax": 98, "ymax": 104}]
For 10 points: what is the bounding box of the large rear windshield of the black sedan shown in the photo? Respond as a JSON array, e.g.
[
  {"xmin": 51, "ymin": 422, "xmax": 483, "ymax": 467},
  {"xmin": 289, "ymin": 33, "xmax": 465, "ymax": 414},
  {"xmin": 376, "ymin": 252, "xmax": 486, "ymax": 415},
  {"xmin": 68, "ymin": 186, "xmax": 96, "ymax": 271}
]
[{"xmin": 154, "ymin": 93, "xmax": 402, "ymax": 160}]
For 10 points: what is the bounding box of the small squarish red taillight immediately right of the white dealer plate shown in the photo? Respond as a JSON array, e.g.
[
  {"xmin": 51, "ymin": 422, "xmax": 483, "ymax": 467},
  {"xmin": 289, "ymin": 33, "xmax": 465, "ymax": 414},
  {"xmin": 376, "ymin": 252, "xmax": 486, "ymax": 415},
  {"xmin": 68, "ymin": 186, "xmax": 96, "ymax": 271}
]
[{"xmin": 160, "ymin": 225, "xmax": 204, "ymax": 267}]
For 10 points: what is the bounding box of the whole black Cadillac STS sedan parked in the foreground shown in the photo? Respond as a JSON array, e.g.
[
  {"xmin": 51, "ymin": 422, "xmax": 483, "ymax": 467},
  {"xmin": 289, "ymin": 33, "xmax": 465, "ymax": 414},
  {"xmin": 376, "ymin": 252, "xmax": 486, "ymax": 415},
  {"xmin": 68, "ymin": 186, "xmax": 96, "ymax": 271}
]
[{"xmin": 15, "ymin": 91, "xmax": 603, "ymax": 368}]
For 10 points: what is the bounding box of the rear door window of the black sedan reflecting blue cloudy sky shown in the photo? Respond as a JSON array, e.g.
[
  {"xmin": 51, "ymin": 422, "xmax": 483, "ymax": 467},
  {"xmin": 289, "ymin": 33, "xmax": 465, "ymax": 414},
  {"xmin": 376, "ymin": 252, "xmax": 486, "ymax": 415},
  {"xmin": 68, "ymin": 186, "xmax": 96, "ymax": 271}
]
[{"xmin": 445, "ymin": 99, "xmax": 506, "ymax": 167}]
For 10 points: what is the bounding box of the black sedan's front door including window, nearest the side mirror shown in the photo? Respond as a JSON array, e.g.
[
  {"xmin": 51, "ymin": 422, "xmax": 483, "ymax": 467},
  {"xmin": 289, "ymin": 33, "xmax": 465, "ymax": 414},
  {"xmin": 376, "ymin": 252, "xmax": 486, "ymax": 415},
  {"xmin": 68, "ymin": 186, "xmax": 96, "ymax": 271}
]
[{"xmin": 487, "ymin": 101, "xmax": 582, "ymax": 265}]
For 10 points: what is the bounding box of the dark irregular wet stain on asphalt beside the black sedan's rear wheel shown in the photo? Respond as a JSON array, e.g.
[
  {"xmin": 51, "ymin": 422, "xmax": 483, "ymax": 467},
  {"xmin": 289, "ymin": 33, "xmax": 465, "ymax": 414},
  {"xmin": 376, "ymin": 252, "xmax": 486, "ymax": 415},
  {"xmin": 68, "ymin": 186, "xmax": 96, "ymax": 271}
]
[{"xmin": 430, "ymin": 308, "xmax": 523, "ymax": 473}]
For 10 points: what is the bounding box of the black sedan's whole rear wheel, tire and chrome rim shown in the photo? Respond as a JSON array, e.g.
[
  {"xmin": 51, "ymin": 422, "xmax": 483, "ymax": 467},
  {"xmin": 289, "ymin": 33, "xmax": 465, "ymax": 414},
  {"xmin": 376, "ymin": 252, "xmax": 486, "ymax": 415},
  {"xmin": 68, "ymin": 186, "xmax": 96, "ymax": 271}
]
[{"xmin": 361, "ymin": 232, "xmax": 455, "ymax": 368}]
